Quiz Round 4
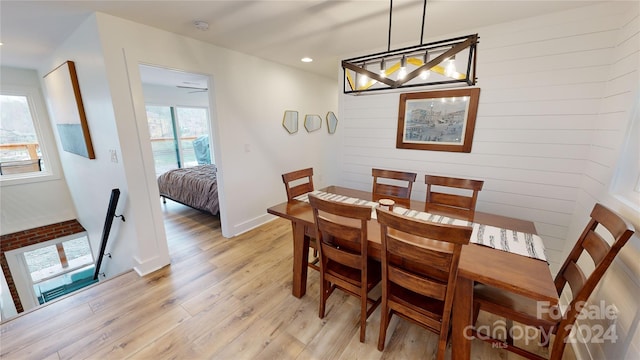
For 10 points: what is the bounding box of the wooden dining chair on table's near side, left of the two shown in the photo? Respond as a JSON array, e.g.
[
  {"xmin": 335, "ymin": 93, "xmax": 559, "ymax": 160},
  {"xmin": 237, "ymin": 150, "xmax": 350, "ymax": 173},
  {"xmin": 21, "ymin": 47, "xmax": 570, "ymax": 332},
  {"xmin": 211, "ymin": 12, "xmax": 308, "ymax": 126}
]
[{"xmin": 309, "ymin": 195, "xmax": 381, "ymax": 342}]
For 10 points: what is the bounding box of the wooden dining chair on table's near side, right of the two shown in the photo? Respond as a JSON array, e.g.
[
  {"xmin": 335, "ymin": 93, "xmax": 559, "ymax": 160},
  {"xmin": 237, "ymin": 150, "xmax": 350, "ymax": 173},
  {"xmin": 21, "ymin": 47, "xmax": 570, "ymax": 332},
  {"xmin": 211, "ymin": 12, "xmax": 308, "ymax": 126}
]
[{"xmin": 376, "ymin": 207, "xmax": 472, "ymax": 359}]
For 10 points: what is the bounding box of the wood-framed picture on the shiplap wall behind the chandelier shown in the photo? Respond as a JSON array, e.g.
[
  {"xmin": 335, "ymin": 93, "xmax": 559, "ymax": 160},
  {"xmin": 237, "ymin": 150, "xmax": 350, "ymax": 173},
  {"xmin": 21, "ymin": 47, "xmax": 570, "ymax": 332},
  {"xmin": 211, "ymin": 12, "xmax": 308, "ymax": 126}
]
[{"xmin": 396, "ymin": 88, "xmax": 480, "ymax": 152}]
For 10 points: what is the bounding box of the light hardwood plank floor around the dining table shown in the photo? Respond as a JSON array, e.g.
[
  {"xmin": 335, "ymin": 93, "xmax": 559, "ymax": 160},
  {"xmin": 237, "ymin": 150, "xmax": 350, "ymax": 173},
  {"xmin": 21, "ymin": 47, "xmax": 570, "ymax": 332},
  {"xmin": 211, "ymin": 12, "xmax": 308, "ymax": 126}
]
[{"xmin": 0, "ymin": 201, "xmax": 568, "ymax": 359}]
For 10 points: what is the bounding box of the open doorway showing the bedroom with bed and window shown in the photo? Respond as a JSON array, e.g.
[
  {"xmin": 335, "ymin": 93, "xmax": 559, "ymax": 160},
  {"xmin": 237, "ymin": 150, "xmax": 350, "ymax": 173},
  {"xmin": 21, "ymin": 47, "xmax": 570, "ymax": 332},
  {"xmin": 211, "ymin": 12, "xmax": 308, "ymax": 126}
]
[{"xmin": 138, "ymin": 64, "xmax": 220, "ymax": 242}]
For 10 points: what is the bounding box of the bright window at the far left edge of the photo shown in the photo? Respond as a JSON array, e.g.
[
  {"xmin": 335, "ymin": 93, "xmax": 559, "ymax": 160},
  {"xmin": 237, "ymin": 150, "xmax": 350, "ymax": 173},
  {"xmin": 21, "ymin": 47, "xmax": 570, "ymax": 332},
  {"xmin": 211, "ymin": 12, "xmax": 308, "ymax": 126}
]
[{"xmin": 0, "ymin": 93, "xmax": 46, "ymax": 176}]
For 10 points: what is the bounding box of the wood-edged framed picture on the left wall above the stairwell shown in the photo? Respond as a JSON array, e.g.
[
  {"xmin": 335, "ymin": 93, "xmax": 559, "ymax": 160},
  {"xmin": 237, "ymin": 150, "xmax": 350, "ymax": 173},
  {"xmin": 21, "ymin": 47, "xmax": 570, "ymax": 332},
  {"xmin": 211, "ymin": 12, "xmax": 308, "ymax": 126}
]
[{"xmin": 44, "ymin": 61, "xmax": 96, "ymax": 159}]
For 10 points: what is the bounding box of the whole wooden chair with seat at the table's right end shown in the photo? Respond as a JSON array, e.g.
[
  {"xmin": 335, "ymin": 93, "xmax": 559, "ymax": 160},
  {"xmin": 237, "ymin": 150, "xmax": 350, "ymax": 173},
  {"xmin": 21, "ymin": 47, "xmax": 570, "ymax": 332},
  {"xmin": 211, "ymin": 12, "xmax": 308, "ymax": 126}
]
[{"xmin": 474, "ymin": 204, "xmax": 634, "ymax": 359}]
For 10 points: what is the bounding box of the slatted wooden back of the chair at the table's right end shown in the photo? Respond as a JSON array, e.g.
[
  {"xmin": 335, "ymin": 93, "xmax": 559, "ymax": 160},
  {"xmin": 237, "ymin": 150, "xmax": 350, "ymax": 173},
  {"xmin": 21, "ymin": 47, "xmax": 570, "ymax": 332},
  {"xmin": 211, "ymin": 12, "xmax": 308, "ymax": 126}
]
[{"xmin": 551, "ymin": 204, "xmax": 634, "ymax": 354}]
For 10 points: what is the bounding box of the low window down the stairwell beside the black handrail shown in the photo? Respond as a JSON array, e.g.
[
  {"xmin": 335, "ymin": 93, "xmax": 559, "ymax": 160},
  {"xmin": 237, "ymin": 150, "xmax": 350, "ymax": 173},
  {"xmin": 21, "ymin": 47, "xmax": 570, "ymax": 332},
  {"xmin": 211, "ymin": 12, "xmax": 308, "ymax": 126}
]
[{"xmin": 22, "ymin": 235, "xmax": 95, "ymax": 304}]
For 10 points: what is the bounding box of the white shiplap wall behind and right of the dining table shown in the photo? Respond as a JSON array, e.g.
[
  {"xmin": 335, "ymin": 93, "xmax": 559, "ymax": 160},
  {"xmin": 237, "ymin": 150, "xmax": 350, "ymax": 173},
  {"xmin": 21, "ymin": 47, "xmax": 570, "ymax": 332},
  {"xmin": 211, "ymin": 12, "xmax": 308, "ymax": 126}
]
[{"xmin": 339, "ymin": 2, "xmax": 640, "ymax": 359}]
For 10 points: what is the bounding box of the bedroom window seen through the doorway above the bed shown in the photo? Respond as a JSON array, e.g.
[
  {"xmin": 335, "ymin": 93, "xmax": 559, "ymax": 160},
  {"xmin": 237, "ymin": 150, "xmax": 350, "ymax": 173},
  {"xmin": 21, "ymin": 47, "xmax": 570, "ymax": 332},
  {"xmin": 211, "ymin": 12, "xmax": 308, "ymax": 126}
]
[{"xmin": 147, "ymin": 105, "xmax": 211, "ymax": 175}]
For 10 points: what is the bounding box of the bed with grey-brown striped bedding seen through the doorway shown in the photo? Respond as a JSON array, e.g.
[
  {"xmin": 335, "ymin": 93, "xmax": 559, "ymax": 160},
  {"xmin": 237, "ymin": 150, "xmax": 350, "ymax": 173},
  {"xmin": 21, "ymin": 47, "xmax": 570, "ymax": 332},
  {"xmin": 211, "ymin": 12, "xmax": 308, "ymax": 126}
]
[{"xmin": 158, "ymin": 164, "xmax": 220, "ymax": 215}]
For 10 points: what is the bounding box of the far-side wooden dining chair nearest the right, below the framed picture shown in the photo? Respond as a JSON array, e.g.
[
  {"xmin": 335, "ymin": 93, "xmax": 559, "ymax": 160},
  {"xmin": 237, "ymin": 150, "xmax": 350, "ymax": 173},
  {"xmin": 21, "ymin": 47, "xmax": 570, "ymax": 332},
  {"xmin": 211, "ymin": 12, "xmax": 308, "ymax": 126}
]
[{"xmin": 424, "ymin": 175, "xmax": 484, "ymax": 221}]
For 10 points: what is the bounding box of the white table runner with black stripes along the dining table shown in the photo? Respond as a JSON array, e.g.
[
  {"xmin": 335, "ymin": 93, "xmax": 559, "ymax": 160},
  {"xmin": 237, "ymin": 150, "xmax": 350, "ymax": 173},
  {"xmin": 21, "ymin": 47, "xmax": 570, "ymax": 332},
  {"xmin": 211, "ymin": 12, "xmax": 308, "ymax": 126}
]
[{"xmin": 295, "ymin": 190, "xmax": 547, "ymax": 261}]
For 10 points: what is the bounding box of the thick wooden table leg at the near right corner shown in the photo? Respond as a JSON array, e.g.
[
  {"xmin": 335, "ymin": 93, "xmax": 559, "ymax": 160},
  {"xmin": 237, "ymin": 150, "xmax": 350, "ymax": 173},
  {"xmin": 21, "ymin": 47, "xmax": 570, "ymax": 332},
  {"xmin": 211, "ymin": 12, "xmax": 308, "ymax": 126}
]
[{"xmin": 451, "ymin": 276, "xmax": 473, "ymax": 360}]
